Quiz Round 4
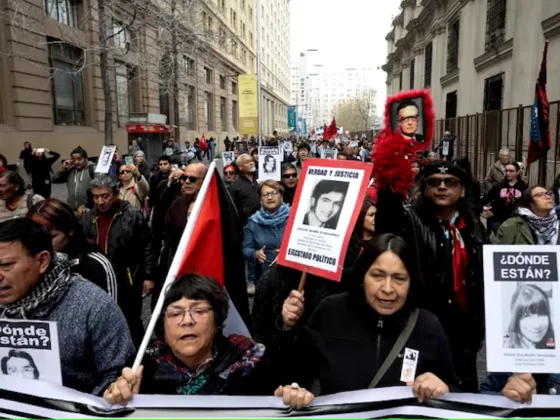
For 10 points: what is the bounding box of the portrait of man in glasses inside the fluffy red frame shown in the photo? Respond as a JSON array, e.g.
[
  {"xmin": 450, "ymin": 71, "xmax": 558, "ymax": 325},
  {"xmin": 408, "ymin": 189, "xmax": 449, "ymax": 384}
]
[{"xmin": 391, "ymin": 96, "xmax": 426, "ymax": 143}]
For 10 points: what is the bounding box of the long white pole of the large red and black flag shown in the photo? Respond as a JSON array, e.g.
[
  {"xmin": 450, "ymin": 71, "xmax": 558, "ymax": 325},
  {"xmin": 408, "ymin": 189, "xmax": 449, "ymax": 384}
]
[{"xmin": 132, "ymin": 162, "xmax": 216, "ymax": 372}]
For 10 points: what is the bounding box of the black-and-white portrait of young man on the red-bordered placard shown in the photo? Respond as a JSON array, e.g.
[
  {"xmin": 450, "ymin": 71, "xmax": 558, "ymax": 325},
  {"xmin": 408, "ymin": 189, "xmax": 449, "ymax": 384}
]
[{"xmin": 303, "ymin": 180, "xmax": 349, "ymax": 229}]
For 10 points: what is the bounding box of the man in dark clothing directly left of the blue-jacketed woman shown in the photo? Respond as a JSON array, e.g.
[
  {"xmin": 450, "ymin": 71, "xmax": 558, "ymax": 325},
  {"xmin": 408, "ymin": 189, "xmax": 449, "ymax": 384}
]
[{"xmin": 229, "ymin": 154, "xmax": 261, "ymax": 225}]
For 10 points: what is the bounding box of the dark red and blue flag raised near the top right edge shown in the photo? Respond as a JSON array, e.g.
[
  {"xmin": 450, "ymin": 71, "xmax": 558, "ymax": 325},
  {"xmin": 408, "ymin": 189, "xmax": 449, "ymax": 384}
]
[{"xmin": 527, "ymin": 41, "xmax": 550, "ymax": 165}]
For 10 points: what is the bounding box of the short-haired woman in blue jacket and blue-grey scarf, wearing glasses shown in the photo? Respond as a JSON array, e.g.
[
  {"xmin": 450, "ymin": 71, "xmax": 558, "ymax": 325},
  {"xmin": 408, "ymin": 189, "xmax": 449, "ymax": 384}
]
[{"xmin": 243, "ymin": 180, "xmax": 290, "ymax": 288}]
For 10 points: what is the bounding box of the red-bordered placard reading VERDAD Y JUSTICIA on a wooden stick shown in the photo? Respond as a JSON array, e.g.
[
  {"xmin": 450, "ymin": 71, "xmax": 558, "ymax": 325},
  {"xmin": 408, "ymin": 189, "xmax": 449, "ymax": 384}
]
[{"xmin": 278, "ymin": 159, "xmax": 371, "ymax": 281}]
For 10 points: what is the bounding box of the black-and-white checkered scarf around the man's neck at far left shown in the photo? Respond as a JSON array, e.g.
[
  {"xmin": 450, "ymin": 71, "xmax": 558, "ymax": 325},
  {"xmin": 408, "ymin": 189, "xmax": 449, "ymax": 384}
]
[{"xmin": 0, "ymin": 253, "xmax": 77, "ymax": 319}]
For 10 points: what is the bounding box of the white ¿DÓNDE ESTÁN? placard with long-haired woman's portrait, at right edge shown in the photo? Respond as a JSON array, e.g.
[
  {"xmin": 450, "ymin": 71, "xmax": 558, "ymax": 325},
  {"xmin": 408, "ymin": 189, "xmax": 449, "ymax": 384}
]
[{"xmin": 484, "ymin": 245, "xmax": 560, "ymax": 373}]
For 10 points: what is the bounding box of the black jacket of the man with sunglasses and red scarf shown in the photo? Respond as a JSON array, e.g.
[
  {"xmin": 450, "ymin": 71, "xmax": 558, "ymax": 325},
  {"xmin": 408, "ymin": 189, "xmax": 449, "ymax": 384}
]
[{"xmin": 375, "ymin": 190, "xmax": 485, "ymax": 348}]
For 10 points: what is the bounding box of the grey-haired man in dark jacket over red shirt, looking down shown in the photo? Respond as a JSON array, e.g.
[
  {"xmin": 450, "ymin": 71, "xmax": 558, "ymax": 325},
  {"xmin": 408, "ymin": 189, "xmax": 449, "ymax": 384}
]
[{"xmin": 82, "ymin": 175, "xmax": 154, "ymax": 345}]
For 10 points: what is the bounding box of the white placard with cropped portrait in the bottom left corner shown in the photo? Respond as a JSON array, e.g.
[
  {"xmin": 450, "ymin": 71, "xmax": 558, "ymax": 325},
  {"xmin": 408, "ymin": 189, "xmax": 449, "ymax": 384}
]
[{"xmin": 0, "ymin": 319, "xmax": 62, "ymax": 385}]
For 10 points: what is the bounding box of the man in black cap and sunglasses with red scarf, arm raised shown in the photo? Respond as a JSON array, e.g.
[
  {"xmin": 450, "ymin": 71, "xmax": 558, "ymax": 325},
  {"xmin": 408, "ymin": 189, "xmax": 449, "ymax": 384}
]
[{"xmin": 375, "ymin": 161, "xmax": 485, "ymax": 392}]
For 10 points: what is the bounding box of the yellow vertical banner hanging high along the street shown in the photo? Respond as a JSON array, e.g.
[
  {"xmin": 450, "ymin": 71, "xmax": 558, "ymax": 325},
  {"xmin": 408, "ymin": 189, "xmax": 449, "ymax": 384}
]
[{"xmin": 237, "ymin": 74, "xmax": 259, "ymax": 135}]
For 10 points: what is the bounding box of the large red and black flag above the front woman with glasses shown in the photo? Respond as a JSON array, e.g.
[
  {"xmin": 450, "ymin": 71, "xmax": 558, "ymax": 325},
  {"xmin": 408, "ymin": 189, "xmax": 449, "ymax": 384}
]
[{"xmin": 175, "ymin": 171, "xmax": 250, "ymax": 325}]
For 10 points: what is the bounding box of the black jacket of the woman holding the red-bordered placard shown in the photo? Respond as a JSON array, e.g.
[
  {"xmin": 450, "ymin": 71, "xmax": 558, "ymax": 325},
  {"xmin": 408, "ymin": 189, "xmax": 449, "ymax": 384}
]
[{"xmin": 287, "ymin": 293, "xmax": 457, "ymax": 395}]
